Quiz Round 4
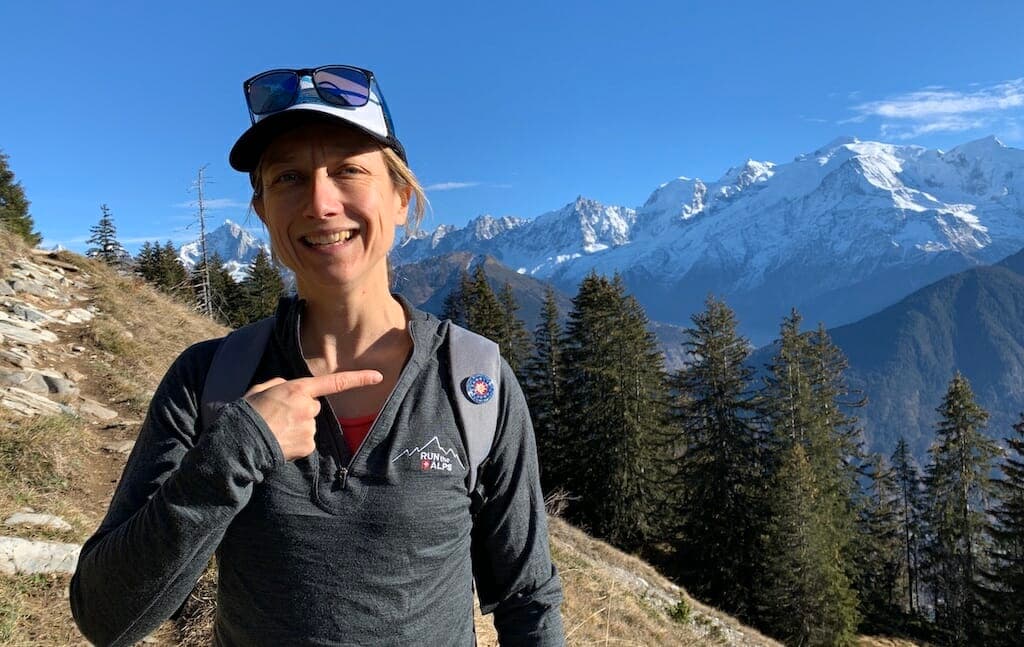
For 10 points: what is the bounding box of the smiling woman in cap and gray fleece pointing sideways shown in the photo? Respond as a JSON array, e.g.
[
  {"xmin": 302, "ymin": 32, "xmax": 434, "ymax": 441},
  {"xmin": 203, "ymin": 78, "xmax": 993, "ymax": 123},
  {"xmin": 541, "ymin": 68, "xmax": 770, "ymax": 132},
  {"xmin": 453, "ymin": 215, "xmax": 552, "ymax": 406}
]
[{"xmin": 71, "ymin": 66, "xmax": 564, "ymax": 645}]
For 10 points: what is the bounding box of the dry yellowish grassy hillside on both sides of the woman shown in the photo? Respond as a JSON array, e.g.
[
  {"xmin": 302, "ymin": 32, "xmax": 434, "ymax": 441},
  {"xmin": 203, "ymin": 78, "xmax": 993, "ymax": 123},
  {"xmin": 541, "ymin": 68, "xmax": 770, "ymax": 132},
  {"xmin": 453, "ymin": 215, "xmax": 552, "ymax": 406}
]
[{"xmin": 0, "ymin": 234, "xmax": 775, "ymax": 645}]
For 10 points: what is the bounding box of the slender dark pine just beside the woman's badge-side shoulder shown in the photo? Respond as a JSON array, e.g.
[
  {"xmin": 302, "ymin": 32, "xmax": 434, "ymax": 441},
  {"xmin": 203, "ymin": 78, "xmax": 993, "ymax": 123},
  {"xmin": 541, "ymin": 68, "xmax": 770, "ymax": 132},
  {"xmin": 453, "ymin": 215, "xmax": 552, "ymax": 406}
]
[{"xmin": 523, "ymin": 287, "xmax": 568, "ymax": 492}]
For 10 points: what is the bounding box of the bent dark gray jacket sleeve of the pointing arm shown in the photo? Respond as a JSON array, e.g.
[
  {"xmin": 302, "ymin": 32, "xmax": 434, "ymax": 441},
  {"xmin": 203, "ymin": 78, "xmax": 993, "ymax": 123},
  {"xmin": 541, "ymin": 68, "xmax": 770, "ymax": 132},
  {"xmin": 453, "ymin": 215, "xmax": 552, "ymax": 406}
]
[{"xmin": 70, "ymin": 342, "xmax": 284, "ymax": 645}]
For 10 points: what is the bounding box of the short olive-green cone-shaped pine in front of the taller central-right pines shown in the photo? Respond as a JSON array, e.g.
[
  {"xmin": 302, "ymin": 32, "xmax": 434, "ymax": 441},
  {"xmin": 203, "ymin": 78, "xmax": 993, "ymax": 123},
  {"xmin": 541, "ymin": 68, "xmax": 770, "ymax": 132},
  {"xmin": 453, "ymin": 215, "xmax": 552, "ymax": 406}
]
[{"xmin": 758, "ymin": 443, "xmax": 858, "ymax": 646}]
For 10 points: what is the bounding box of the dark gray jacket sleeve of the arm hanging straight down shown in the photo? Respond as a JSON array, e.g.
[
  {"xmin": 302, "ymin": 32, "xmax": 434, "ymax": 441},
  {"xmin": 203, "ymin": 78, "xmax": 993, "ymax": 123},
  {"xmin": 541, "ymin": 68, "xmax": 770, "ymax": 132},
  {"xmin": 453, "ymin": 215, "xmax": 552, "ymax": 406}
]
[{"xmin": 472, "ymin": 360, "xmax": 565, "ymax": 647}]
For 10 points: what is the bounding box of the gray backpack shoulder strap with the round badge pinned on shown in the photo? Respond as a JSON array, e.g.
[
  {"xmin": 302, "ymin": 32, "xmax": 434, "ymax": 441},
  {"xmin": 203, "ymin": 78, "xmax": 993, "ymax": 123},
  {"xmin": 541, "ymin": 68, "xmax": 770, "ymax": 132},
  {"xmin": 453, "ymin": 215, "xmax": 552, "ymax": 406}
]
[{"xmin": 449, "ymin": 324, "xmax": 502, "ymax": 494}]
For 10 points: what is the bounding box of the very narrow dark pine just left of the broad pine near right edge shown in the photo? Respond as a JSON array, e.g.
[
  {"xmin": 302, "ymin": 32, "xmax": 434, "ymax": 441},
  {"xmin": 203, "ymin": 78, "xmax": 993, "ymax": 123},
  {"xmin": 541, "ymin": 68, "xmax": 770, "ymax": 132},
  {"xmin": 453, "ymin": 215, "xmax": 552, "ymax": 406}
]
[{"xmin": 892, "ymin": 436, "xmax": 924, "ymax": 615}]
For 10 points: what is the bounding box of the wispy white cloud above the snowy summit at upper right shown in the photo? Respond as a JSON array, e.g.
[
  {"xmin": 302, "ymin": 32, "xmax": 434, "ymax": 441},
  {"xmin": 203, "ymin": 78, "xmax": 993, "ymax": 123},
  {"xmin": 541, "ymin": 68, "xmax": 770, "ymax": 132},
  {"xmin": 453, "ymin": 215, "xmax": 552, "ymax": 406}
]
[{"xmin": 840, "ymin": 79, "xmax": 1024, "ymax": 139}]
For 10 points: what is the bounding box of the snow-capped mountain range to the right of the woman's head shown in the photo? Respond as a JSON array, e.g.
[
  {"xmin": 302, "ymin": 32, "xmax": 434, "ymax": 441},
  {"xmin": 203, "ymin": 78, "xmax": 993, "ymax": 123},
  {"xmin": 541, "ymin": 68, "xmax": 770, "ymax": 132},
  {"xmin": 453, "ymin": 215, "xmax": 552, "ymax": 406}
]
[{"xmin": 393, "ymin": 137, "xmax": 1024, "ymax": 343}]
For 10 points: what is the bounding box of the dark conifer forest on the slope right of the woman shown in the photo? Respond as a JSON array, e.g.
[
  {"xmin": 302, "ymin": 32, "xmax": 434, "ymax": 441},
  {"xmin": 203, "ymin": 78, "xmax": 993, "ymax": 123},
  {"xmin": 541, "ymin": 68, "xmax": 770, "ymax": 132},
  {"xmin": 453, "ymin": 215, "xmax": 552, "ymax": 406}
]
[{"xmin": 444, "ymin": 270, "xmax": 1024, "ymax": 646}]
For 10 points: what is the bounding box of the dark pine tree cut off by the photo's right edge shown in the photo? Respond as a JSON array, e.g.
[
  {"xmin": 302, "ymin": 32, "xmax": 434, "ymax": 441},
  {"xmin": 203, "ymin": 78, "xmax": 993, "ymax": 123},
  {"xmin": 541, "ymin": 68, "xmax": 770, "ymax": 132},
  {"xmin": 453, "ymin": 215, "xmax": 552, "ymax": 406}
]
[{"xmin": 986, "ymin": 414, "xmax": 1024, "ymax": 647}]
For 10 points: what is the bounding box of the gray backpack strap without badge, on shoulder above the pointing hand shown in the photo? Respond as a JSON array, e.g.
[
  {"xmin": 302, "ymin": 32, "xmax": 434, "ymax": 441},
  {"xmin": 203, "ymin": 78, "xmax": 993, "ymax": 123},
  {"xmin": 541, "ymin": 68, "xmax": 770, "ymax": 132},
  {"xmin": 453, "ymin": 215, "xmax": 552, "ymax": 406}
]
[{"xmin": 200, "ymin": 316, "xmax": 274, "ymax": 431}]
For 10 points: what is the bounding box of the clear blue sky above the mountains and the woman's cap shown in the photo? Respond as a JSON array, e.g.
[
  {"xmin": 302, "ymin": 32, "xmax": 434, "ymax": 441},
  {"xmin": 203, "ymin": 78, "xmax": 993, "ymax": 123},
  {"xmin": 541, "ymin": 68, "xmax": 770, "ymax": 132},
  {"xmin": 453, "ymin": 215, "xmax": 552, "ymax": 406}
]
[{"xmin": 0, "ymin": 0, "xmax": 1024, "ymax": 251}]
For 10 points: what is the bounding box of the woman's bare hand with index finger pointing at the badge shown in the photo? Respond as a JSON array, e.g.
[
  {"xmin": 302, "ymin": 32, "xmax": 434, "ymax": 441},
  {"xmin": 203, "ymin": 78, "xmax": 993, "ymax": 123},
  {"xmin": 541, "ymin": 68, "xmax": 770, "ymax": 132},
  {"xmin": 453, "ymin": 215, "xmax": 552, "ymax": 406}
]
[{"xmin": 245, "ymin": 371, "xmax": 384, "ymax": 461}]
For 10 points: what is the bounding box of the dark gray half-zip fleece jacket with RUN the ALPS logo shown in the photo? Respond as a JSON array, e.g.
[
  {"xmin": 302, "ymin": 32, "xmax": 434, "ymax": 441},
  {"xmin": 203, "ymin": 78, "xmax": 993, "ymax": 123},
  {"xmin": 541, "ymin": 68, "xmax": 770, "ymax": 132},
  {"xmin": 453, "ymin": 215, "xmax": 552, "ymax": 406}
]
[{"xmin": 71, "ymin": 300, "xmax": 564, "ymax": 646}]
